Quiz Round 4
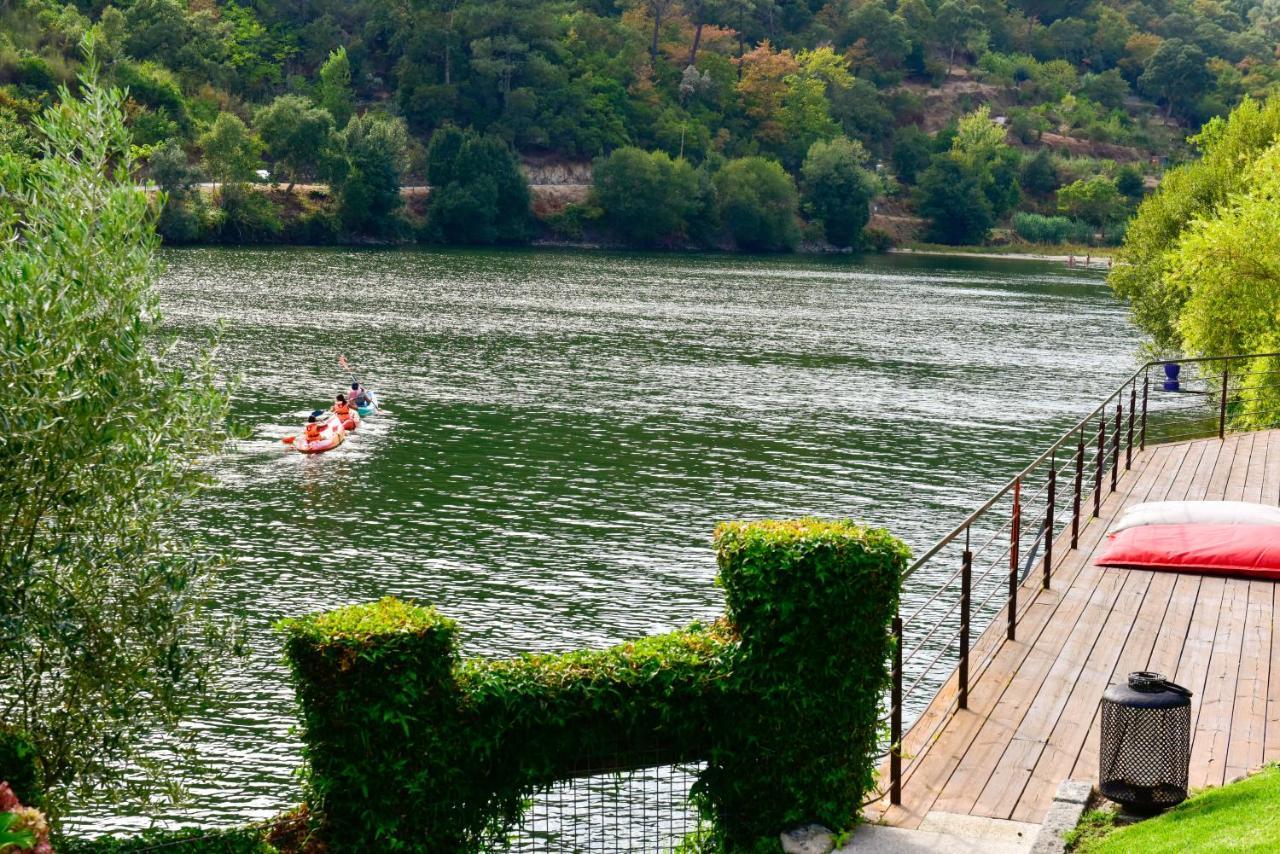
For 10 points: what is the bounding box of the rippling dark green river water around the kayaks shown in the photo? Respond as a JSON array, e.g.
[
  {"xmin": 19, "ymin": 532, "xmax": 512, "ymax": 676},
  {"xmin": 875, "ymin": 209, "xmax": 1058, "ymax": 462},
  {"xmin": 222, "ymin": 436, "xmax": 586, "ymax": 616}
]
[{"xmin": 77, "ymin": 248, "xmax": 1137, "ymax": 831}]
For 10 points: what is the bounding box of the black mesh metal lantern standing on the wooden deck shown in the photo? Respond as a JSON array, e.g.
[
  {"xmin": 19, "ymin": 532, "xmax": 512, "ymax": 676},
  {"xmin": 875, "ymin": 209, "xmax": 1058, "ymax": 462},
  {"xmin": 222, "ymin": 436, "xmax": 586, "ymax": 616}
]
[{"xmin": 1098, "ymin": 672, "xmax": 1192, "ymax": 812}]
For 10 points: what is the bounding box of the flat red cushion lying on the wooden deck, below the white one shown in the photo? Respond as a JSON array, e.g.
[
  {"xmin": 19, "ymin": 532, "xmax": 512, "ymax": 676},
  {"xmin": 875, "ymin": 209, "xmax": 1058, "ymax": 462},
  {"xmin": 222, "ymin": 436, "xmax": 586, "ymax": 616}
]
[{"xmin": 1093, "ymin": 525, "xmax": 1280, "ymax": 580}]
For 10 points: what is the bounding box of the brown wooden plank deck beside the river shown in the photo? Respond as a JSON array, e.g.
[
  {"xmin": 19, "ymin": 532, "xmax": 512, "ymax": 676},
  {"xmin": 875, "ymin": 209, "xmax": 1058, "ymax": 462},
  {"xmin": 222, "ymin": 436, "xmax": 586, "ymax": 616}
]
[{"xmin": 868, "ymin": 430, "xmax": 1280, "ymax": 827}]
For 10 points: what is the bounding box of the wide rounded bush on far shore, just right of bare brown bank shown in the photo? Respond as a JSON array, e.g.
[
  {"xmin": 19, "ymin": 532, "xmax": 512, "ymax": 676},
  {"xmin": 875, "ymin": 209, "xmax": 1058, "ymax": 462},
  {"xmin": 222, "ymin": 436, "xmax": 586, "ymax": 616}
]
[{"xmin": 591, "ymin": 147, "xmax": 713, "ymax": 246}]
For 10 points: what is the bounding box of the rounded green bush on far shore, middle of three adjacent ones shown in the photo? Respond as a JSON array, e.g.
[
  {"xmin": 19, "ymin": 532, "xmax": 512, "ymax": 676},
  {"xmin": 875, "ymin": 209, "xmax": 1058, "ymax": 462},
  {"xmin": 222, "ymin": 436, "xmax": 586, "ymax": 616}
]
[{"xmin": 712, "ymin": 157, "xmax": 800, "ymax": 252}]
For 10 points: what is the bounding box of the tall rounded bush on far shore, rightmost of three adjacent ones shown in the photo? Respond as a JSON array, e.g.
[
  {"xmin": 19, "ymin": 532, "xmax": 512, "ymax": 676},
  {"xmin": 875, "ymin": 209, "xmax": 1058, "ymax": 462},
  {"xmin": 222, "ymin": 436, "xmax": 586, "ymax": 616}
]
[{"xmin": 800, "ymin": 137, "xmax": 879, "ymax": 248}]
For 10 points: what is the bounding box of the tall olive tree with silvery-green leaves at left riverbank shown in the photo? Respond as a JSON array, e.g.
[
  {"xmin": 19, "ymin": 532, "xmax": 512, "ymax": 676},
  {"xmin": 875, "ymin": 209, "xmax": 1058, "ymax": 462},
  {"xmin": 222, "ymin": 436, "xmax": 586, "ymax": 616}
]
[{"xmin": 0, "ymin": 56, "xmax": 234, "ymax": 812}]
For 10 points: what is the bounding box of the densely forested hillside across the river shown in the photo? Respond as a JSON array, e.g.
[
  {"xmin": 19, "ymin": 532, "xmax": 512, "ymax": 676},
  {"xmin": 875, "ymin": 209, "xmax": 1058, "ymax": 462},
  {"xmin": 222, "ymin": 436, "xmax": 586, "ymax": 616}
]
[{"xmin": 0, "ymin": 0, "xmax": 1280, "ymax": 250}]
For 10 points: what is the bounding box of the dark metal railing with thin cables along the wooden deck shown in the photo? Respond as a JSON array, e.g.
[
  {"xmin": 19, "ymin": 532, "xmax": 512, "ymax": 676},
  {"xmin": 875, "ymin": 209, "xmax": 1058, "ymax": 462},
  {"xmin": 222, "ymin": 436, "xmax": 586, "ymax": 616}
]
[{"xmin": 879, "ymin": 353, "xmax": 1280, "ymax": 804}]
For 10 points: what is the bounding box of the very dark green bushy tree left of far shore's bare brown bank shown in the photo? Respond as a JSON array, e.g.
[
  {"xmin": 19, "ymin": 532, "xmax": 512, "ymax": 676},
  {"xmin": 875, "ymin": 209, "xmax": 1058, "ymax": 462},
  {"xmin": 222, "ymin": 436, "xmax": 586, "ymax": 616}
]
[{"xmin": 426, "ymin": 125, "xmax": 532, "ymax": 243}]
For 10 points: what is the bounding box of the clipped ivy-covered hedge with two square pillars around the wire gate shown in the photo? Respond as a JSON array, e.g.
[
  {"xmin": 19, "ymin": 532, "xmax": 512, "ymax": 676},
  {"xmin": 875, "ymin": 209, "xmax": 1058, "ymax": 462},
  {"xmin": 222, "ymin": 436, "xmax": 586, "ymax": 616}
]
[{"xmin": 279, "ymin": 519, "xmax": 908, "ymax": 851}]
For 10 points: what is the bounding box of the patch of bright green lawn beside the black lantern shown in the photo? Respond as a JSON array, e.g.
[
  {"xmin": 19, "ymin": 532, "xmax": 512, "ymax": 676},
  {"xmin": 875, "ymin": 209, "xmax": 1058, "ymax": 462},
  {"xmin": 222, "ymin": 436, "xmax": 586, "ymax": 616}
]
[{"xmin": 1075, "ymin": 766, "xmax": 1280, "ymax": 854}]
